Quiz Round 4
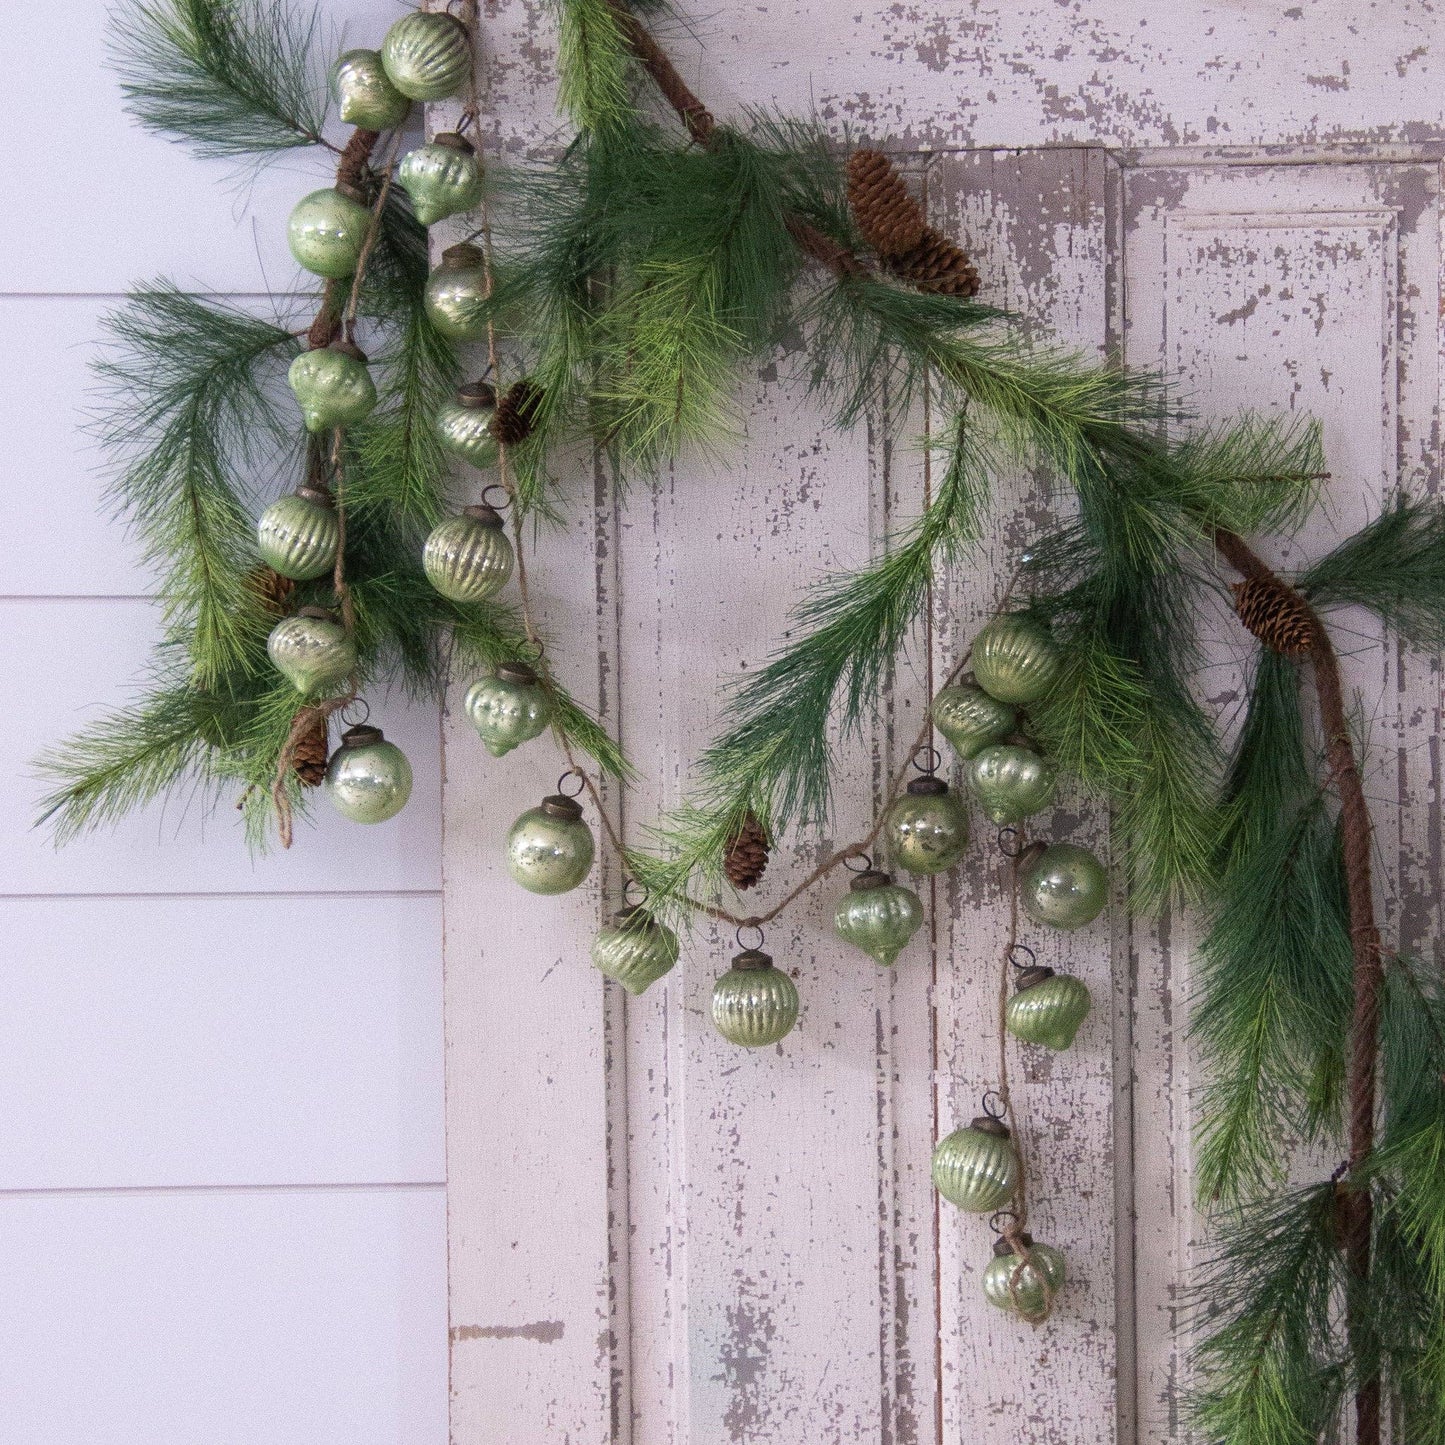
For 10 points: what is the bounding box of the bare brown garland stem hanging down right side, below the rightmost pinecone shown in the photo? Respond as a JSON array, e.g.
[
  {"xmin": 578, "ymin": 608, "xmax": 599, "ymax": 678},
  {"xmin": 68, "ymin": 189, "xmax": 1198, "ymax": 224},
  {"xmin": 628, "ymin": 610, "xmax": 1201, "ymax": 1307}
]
[{"xmin": 1214, "ymin": 530, "xmax": 1384, "ymax": 1445}]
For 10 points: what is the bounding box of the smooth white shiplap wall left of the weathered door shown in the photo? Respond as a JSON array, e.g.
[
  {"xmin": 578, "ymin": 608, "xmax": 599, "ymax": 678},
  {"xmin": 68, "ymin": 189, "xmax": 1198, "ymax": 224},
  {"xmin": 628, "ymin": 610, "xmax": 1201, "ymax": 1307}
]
[{"xmin": 0, "ymin": 0, "xmax": 447, "ymax": 1445}]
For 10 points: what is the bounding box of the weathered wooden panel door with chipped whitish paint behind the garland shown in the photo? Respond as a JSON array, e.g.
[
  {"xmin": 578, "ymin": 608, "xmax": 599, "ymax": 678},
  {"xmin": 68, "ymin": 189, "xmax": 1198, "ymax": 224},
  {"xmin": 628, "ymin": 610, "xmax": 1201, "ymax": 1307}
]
[{"xmin": 445, "ymin": 0, "xmax": 1445, "ymax": 1445}]
